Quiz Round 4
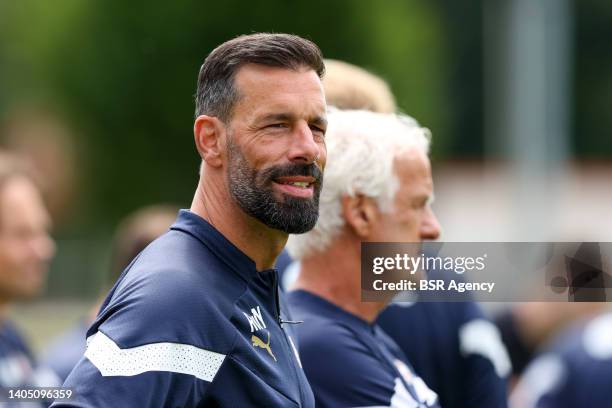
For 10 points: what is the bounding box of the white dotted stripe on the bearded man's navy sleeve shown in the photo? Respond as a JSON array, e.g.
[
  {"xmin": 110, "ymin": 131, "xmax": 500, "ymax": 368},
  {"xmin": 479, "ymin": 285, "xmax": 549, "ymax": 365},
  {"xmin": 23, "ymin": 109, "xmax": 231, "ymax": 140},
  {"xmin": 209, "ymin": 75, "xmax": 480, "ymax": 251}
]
[{"xmin": 85, "ymin": 331, "xmax": 225, "ymax": 382}]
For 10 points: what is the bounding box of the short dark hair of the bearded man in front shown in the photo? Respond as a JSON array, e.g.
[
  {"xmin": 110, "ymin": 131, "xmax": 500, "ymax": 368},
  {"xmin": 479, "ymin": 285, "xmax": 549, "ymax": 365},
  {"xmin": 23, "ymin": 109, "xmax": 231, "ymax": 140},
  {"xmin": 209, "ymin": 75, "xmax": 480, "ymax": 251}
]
[{"xmin": 195, "ymin": 33, "xmax": 325, "ymax": 121}]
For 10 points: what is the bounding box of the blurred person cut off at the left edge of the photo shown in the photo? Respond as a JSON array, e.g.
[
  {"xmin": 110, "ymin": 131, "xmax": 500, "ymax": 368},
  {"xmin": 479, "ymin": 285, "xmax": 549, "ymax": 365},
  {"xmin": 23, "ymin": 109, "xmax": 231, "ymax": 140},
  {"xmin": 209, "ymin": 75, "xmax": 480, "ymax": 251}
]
[{"xmin": 0, "ymin": 152, "xmax": 59, "ymax": 402}]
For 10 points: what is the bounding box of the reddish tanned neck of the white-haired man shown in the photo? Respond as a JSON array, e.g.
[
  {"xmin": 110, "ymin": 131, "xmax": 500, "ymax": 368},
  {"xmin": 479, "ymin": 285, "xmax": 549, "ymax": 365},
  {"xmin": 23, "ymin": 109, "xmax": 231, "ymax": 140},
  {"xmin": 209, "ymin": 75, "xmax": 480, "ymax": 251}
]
[{"xmin": 292, "ymin": 237, "xmax": 388, "ymax": 323}]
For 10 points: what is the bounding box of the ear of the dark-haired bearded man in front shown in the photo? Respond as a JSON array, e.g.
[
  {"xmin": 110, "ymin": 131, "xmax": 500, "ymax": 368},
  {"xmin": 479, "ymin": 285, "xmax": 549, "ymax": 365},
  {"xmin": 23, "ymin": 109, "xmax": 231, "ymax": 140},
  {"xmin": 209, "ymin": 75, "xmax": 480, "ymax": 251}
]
[{"xmin": 193, "ymin": 115, "xmax": 225, "ymax": 167}]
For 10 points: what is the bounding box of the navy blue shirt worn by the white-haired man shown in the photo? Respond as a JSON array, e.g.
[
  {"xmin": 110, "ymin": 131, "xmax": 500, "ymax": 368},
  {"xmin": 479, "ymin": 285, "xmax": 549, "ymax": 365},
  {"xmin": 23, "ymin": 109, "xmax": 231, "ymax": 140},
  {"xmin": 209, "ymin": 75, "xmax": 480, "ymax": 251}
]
[{"xmin": 288, "ymin": 290, "xmax": 439, "ymax": 408}]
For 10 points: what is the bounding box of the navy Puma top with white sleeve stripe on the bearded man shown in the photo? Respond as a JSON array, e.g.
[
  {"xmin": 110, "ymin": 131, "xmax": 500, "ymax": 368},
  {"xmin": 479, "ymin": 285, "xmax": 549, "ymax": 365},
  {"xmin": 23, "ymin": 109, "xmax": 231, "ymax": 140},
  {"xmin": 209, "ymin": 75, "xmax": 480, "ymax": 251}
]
[{"xmin": 54, "ymin": 210, "xmax": 314, "ymax": 407}]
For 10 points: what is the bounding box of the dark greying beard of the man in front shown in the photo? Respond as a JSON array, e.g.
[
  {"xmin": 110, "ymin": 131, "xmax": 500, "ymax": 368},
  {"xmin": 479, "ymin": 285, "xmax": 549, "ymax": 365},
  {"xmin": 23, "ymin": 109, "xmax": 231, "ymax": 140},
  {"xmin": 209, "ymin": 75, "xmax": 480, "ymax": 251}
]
[{"xmin": 227, "ymin": 136, "xmax": 323, "ymax": 234}]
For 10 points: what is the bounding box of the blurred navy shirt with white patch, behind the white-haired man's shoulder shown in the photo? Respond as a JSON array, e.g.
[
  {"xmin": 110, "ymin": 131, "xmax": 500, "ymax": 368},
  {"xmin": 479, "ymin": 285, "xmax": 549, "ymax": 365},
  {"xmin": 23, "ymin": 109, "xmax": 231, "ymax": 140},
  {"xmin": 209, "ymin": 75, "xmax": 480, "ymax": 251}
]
[{"xmin": 377, "ymin": 302, "xmax": 511, "ymax": 408}]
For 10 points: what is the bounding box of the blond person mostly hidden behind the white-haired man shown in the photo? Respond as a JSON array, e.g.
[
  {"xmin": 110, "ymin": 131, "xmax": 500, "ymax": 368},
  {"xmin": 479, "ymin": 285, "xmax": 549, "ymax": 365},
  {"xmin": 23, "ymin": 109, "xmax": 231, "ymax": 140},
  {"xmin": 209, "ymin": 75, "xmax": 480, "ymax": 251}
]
[{"xmin": 283, "ymin": 59, "xmax": 511, "ymax": 408}]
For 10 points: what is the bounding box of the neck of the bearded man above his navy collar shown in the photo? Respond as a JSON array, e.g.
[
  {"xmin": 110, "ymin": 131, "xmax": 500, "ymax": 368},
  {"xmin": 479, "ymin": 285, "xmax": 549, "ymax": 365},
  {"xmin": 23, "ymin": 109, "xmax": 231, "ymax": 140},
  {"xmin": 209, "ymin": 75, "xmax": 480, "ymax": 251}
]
[{"xmin": 191, "ymin": 182, "xmax": 287, "ymax": 271}]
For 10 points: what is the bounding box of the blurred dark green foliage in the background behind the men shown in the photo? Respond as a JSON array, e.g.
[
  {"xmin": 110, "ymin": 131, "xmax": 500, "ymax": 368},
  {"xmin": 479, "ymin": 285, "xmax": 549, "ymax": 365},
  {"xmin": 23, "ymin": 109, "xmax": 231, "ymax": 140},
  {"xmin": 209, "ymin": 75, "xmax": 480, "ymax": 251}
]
[{"xmin": 0, "ymin": 0, "xmax": 612, "ymax": 296}]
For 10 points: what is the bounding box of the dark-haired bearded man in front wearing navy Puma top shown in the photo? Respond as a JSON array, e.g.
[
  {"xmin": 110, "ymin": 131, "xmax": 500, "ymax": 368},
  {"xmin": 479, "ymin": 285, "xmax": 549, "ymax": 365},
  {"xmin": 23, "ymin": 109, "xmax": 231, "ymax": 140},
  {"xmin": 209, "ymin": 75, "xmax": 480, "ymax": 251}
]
[{"xmin": 55, "ymin": 34, "xmax": 326, "ymax": 407}]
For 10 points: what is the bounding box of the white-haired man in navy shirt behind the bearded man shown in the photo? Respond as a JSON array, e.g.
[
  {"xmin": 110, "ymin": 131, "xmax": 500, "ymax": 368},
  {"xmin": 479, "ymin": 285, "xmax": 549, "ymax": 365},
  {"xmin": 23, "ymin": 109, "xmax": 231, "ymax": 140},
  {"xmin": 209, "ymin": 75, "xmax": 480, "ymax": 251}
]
[{"xmin": 287, "ymin": 110, "xmax": 439, "ymax": 407}]
